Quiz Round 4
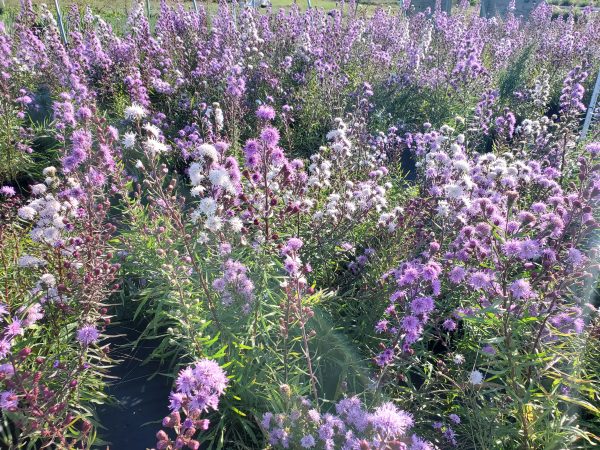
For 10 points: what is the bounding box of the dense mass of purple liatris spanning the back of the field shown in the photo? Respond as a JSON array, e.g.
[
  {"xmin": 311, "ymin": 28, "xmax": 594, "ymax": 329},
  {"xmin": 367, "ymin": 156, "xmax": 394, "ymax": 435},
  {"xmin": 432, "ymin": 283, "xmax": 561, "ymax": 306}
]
[{"xmin": 0, "ymin": 2, "xmax": 598, "ymax": 171}]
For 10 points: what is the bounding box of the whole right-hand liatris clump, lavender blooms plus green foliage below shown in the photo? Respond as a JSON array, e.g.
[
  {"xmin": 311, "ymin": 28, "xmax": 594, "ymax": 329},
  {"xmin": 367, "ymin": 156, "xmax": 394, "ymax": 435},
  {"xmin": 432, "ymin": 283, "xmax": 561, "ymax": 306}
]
[{"xmin": 376, "ymin": 122, "xmax": 599, "ymax": 448}]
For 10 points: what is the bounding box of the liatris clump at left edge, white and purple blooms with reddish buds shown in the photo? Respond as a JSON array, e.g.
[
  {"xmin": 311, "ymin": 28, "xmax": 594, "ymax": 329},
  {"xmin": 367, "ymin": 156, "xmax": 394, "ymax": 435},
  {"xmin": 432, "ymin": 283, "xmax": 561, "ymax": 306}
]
[{"xmin": 0, "ymin": 167, "xmax": 118, "ymax": 448}]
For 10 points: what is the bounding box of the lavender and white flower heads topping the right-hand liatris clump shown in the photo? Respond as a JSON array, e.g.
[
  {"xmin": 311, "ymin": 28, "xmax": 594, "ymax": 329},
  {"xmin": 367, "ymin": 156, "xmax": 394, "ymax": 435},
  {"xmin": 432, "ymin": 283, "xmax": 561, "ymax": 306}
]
[{"xmin": 376, "ymin": 130, "xmax": 600, "ymax": 360}]
